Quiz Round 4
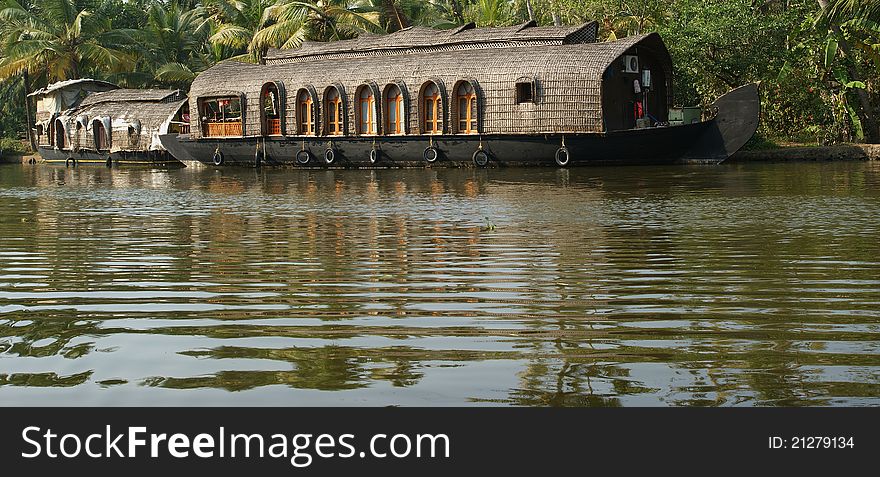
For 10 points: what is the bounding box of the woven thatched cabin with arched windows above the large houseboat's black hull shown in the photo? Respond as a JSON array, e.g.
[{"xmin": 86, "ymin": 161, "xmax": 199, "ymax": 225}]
[{"xmin": 190, "ymin": 22, "xmax": 672, "ymax": 138}]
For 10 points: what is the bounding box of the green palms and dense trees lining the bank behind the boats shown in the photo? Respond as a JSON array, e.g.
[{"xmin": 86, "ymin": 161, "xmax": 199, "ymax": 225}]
[{"xmin": 0, "ymin": 0, "xmax": 880, "ymax": 149}]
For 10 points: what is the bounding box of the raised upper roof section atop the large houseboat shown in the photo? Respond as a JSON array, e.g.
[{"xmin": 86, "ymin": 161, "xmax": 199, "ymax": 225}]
[{"xmin": 266, "ymin": 21, "xmax": 599, "ymax": 64}]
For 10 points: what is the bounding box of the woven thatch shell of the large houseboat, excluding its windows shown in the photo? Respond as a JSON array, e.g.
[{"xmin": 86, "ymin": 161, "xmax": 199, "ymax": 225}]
[{"xmin": 190, "ymin": 27, "xmax": 672, "ymax": 136}]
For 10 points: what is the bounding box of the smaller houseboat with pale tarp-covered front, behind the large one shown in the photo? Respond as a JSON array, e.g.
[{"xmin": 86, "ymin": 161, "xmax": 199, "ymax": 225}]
[{"xmin": 31, "ymin": 79, "xmax": 189, "ymax": 166}]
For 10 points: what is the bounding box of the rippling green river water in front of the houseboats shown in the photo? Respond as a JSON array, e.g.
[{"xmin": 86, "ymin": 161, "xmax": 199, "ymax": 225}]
[{"xmin": 0, "ymin": 162, "xmax": 880, "ymax": 406}]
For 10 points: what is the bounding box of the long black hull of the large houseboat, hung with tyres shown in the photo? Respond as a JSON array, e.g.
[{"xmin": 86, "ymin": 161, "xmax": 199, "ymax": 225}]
[{"xmin": 160, "ymin": 85, "xmax": 760, "ymax": 168}]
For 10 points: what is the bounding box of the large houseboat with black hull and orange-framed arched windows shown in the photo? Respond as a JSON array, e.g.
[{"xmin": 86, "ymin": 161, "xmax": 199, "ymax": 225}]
[{"xmin": 161, "ymin": 22, "xmax": 760, "ymax": 167}]
